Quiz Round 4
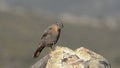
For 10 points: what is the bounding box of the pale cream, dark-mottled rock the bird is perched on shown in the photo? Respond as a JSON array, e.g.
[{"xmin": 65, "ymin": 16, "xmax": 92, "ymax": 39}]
[{"xmin": 32, "ymin": 46, "xmax": 111, "ymax": 68}]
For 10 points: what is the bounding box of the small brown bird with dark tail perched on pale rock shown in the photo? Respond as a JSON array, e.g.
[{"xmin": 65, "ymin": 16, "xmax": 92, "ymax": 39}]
[{"xmin": 32, "ymin": 19, "xmax": 64, "ymax": 58}]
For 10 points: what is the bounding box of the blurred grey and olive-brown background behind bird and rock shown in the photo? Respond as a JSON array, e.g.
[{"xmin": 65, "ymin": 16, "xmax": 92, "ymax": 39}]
[{"xmin": 0, "ymin": 0, "xmax": 120, "ymax": 68}]
